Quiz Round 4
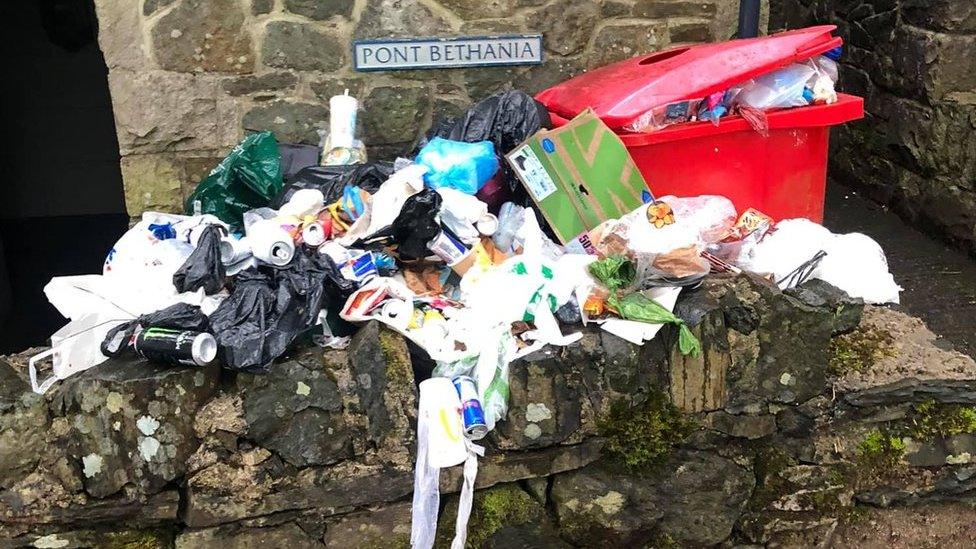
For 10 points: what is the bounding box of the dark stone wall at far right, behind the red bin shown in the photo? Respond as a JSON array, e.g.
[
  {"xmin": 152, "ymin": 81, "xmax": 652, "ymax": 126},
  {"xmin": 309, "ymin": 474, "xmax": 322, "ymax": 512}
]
[{"xmin": 770, "ymin": 0, "xmax": 976, "ymax": 253}]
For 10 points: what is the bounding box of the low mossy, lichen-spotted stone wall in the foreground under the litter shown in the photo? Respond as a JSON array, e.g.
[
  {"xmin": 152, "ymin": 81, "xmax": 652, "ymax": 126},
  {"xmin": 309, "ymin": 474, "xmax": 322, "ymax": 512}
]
[{"xmin": 0, "ymin": 276, "xmax": 976, "ymax": 549}]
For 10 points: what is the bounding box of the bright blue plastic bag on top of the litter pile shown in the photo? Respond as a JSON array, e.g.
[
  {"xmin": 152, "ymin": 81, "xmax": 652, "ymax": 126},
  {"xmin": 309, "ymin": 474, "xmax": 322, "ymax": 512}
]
[{"xmin": 417, "ymin": 137, "xmax": 498, "ymax": 194}]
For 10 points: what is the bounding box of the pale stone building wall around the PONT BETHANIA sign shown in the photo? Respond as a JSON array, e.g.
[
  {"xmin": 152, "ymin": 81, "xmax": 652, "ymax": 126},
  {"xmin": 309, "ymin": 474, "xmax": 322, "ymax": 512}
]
[{"xmin": 95, "ymin": 0, "xmax": 738, "ymax": 216}]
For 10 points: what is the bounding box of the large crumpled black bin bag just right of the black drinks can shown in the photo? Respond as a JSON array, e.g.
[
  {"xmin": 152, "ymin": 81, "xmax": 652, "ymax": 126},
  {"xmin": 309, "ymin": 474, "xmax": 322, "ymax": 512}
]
[{"xmin": 210, "ymin": 250, "xmax": 356, "ymax": 372}]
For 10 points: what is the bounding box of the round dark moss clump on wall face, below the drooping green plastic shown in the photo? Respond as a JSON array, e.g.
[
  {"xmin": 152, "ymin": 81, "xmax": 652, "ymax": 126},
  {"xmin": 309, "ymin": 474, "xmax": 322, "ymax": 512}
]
[{"xmin": 598, "ymin": 391, "xmax": 695, "ymax": 471}]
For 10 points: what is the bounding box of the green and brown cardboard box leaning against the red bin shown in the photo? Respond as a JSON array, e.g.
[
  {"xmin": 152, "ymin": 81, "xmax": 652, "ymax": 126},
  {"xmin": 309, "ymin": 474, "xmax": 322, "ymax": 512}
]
[{"xmin": 505, "ymin": 110, "xmax": 654, "ymax": 251}]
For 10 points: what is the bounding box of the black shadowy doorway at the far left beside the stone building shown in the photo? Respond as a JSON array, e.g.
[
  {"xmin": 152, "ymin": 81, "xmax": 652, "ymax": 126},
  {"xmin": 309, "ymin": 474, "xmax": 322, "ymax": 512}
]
[{"xmin": 0, "ymin": 0, "xmax": 128, "ymax": 353}]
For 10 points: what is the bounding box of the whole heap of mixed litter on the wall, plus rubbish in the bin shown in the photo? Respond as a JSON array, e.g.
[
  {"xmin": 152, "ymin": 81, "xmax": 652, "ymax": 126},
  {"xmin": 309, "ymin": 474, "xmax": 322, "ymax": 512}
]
[{"xmin": 30, "ymin": 26, "xmax": 900, "ymax": 547}]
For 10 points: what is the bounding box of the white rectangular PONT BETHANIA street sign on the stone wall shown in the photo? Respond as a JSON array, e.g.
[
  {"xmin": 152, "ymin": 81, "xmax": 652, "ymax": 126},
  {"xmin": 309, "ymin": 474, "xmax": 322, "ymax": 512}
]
[{"xmin": 353, "ymin": 34, "xmax": 542, "ymax": 71}]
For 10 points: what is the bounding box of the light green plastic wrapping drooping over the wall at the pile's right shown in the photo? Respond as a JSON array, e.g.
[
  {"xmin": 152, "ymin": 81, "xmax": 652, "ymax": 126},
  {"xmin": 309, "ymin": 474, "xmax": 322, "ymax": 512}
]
[{"xmin": 590, "ymin": 255, "xmax": 701, "ymax": 356}]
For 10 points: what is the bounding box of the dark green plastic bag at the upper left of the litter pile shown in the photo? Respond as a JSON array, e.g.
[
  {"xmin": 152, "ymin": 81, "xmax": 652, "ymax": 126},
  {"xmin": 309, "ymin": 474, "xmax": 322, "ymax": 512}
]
[{"xmin": 184, "ymin": 132, "xmax": 284, "ymax": 231}]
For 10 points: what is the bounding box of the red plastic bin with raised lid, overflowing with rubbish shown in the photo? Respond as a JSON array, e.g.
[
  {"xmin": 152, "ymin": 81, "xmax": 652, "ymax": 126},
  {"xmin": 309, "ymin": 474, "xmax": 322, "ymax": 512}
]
[{"xmin": 536, "ymin": 26, "xmax": 864, "ymax": 223}]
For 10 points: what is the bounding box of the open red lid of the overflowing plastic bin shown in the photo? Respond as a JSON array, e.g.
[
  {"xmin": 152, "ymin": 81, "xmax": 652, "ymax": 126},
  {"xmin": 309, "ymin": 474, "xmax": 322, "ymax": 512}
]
[{"xmin": 536, "ymin": 25, "xmax": 843, "ymax": 128}]
